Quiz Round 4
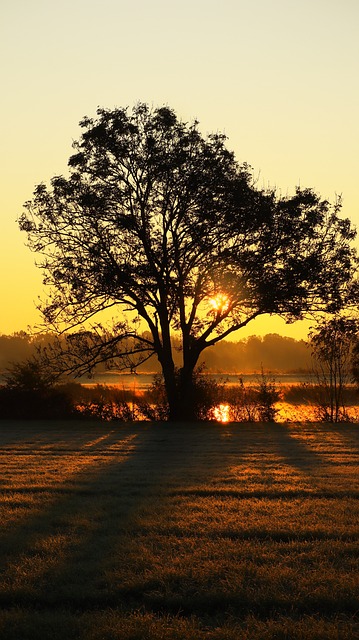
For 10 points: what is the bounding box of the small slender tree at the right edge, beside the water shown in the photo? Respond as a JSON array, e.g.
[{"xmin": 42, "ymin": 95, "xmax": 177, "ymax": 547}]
[{"xmin": 310, "ymin": 316, "xmax": 359, "ymax": 422}]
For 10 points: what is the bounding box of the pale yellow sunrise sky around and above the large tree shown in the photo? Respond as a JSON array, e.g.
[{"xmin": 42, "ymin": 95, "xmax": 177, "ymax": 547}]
[{"xmin": 0, "ymin": 0, "xmax": 359, "ymax": 340}]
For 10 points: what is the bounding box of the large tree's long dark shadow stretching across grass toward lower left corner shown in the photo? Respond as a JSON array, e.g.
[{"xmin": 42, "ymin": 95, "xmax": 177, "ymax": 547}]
[{"xmin": 0, "ymin": 424, "xmax": 242, "ymax": 608}]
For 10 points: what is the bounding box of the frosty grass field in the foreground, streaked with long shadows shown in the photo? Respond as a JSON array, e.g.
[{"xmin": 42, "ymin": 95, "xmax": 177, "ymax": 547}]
[{"xmin": 0, "ymin": 421, "xmax": 359, "ymax": 640}]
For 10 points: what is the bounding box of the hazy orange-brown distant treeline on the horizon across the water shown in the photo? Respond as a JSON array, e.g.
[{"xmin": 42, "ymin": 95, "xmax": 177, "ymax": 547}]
[{"xmin": 0, "ymin": 332, "xmax": 311, "ymax": 373}]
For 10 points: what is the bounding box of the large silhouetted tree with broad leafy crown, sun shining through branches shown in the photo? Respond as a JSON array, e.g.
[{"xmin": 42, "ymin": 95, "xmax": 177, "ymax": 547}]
[{"xmin": 20, "ymin": 104, "xmax": 356, "ymax": 420}]
